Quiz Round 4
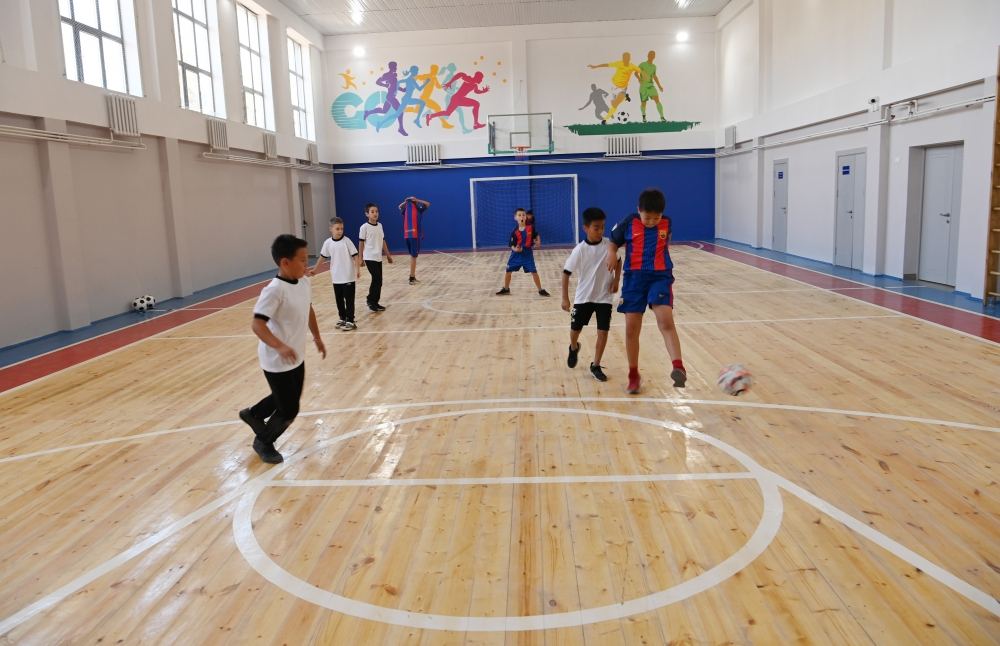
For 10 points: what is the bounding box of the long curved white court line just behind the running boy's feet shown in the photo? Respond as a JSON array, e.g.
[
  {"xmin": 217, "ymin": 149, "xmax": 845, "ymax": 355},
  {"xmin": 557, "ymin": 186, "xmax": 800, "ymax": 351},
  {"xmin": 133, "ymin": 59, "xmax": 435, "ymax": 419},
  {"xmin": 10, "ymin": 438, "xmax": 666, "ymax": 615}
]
[{"xmin": 0, "ymin": 397, "xmax": 1000, "ymax": 464}]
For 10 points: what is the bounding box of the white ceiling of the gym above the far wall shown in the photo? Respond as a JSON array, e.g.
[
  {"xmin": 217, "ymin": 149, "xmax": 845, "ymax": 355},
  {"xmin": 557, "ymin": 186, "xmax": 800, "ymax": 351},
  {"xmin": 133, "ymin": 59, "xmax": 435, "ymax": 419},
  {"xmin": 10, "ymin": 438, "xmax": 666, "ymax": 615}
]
[{"xmin": 282, "ymin": 0, "xmax": 729, "ymax": 36}]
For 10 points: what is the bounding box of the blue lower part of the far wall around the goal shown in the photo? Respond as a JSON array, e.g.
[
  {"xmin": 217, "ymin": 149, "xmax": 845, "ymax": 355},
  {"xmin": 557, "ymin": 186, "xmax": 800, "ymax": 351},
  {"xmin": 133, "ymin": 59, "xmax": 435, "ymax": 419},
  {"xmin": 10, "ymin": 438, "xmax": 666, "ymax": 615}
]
[{"xmin": 334, "ymin": 150, "xmax": 715, "ymax": 252}]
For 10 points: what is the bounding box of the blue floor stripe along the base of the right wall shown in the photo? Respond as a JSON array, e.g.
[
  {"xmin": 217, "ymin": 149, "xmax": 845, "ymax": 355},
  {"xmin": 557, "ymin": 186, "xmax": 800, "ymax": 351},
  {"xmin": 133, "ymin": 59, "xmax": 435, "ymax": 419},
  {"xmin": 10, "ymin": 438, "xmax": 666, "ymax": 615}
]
[{"xmin": 712, "ymin": 238, "xmax": 1000, "ymax": 316}]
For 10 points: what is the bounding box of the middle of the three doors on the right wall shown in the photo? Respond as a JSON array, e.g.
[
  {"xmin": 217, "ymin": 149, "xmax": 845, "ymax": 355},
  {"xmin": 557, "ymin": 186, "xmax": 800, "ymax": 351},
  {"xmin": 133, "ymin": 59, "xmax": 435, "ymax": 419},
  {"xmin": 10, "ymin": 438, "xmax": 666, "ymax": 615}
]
[{"xmin": 833, "ymin": 153, "xmax": 865, "ymax": 269}]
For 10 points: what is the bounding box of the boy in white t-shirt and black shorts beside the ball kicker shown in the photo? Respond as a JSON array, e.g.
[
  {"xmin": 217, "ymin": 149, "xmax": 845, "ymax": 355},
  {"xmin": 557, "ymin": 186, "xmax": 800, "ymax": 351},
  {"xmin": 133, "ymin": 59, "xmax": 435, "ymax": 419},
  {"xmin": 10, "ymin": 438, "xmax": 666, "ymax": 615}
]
[{"xmin": 562, "ymin": 207, "xmax": 622, "ymax": 381}]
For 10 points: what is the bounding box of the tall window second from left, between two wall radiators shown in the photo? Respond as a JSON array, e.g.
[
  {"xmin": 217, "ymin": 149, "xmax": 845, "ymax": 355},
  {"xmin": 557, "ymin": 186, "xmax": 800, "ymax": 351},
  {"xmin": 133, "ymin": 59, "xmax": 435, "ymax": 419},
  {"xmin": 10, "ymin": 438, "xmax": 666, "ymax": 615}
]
[{"xmin": 173, "ymin": 0, "xmax": 225, "ymax": 117}]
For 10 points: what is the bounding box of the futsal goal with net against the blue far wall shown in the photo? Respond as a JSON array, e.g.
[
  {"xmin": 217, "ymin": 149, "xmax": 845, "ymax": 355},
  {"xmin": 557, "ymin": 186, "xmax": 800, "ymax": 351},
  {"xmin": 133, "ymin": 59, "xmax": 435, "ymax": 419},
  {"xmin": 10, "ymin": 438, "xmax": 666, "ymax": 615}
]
[{"xmin": 469, "ymin": 174, "xmax": 580, "ymax": 249}]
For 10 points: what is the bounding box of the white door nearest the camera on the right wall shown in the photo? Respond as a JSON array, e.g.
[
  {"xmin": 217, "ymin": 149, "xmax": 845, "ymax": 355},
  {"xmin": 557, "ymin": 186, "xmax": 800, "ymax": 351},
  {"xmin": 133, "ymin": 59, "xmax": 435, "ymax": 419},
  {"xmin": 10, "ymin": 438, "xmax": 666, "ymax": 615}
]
[{"xmin": 917, "ymin": 151, "xmax": 962, "ymax": 286}]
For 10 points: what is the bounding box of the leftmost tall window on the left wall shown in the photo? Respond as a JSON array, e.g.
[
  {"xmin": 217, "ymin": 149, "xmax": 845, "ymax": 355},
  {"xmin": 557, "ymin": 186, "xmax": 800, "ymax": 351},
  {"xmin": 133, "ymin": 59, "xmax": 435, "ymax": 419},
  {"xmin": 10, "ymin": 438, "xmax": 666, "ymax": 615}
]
[{"xmin": 59, "ymin": 0, "xmax": 142, "ymax": 95}]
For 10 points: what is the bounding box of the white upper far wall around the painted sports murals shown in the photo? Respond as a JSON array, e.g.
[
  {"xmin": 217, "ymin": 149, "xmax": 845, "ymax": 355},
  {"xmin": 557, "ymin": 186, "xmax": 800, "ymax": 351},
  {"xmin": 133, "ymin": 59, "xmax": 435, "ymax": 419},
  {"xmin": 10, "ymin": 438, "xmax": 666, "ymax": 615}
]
[{"xmin": 324, "ymin": 18, "xmax": 718, "ymax": 163}]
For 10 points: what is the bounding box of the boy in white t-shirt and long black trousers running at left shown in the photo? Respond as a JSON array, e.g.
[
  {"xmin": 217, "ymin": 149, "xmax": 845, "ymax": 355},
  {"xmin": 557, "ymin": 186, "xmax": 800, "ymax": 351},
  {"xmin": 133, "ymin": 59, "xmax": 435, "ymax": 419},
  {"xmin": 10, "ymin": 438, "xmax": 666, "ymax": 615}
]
[{"xmin": 240, "ymin": 233, "xmax": 326, "ymax": 464}]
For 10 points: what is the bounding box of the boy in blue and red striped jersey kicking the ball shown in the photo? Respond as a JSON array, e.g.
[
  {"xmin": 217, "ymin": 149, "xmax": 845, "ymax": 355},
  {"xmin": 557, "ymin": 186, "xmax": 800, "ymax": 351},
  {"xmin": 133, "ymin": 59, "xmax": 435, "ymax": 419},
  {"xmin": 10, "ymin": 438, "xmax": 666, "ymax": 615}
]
[{"xmin": 607, "ymin": 188, "xmax": 687, "ymax": 395}]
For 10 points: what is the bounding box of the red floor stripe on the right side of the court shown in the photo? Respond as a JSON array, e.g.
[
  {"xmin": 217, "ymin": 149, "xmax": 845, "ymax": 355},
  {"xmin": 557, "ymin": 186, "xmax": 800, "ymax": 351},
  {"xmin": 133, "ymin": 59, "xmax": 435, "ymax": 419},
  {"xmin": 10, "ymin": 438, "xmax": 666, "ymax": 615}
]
[{"xmin": 696, "ymin": 242, "xmax": 1000, "ymax": 343}]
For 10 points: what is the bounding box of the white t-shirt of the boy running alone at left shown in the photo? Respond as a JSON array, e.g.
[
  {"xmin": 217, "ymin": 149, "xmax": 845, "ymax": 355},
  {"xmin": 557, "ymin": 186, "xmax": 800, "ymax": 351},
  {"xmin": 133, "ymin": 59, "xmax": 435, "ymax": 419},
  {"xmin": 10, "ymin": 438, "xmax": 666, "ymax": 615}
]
[{"xmin": 253, "ymin": 276, "xmax": 312, "ymax": 372}]
